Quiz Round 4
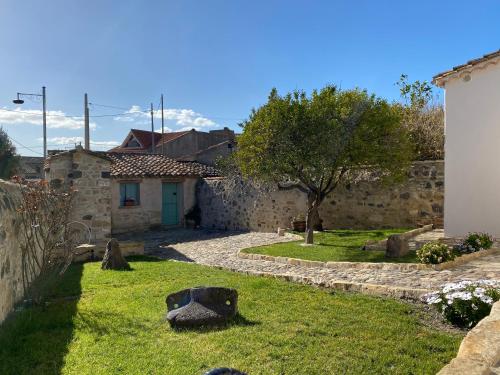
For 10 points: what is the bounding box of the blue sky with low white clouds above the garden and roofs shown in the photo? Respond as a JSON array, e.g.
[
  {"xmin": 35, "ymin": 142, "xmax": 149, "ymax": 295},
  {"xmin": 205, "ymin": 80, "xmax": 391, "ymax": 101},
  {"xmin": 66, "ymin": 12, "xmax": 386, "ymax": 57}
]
[{"xmin": 0, "ymin": 0, "xmax": 500, "ymax": 155}]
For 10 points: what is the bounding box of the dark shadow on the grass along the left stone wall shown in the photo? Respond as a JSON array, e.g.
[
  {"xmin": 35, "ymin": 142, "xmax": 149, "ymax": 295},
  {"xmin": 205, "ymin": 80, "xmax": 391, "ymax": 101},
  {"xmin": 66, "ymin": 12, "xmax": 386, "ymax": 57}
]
[{"xmin": 0, "ymin": 264, "xmax": 83, "ymax": 375}]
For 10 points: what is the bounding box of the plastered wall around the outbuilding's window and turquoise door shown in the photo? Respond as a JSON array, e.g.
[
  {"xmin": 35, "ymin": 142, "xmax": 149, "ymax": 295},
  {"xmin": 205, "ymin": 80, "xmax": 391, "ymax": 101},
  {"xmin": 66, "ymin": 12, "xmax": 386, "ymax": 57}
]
[{"xmin": 111, "ymin": 178, "xmax": 197, "ymax": 233}]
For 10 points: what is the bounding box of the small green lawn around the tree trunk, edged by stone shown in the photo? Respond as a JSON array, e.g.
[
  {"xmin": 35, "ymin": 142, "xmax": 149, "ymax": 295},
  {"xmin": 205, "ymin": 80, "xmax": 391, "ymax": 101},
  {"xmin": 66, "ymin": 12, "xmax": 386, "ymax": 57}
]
[{"xmin": 243, "ymin": 229, "xmax": 419, "ymax": 263}]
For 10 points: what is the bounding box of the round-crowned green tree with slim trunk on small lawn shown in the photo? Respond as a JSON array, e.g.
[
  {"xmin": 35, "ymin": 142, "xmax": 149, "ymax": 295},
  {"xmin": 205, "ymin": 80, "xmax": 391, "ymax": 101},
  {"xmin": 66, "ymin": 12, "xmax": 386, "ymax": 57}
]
[{"xmin": 234, "ymin": 85, "xmax": 411, "ymax": 244}]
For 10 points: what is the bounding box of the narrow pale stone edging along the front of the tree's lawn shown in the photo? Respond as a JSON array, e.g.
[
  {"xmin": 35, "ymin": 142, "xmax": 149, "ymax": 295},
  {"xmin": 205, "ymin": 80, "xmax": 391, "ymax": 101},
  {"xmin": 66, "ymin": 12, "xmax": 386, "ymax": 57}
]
[{"xmin": 237, "ymin": 249, "xmax": 500, "ymax": 271}]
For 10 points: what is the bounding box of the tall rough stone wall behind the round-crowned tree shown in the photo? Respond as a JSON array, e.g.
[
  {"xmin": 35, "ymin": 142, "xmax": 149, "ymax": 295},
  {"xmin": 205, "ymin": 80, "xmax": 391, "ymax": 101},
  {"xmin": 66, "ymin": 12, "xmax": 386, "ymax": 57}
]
[{"xmin": 197, "ymin": 161, "xmax": 444, "ymax": 232}]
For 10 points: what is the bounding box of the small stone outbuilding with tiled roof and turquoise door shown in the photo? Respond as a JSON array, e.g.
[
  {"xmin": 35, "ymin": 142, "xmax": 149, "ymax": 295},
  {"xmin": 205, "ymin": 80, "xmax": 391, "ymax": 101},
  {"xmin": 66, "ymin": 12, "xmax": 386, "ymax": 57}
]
[{"xmin": 45, "ymin": 147, "xmax": 217, "ymax": 241}]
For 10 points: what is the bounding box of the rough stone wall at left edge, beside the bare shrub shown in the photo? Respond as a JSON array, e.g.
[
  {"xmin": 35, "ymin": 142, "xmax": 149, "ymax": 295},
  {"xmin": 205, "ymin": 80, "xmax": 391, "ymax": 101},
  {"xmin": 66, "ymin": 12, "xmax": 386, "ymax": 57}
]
[{"xmin": 0, "ymin": 180, "xmax": 23, "ymax": 323}]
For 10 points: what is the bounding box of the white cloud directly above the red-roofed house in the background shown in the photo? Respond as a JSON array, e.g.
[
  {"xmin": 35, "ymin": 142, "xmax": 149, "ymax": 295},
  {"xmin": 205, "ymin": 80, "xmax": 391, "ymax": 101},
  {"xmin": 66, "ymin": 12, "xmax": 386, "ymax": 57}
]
[{"xmin": 114, "ymin": 105, "xmax": 220, "ymax": 130}]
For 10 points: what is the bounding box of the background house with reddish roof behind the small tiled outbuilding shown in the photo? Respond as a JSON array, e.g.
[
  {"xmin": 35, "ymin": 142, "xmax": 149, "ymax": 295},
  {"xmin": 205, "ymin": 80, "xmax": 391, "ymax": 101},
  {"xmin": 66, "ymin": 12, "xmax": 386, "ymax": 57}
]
[{"xmin": 109, "ymin": 128, "xmax": 235, "ymax": 165}]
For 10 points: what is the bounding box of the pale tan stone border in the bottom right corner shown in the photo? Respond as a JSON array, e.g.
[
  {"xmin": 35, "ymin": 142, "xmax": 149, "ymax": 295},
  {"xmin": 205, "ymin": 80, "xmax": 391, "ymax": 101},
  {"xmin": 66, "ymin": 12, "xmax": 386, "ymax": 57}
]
[{"xmin": 438, "ymin": 301, "xmax": 500, "ymax": 375}]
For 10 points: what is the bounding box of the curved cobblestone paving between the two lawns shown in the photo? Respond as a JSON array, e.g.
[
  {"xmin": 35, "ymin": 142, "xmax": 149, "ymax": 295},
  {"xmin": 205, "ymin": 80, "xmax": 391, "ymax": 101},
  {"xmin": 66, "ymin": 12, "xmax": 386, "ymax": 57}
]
[{"xmin": 122, "ymin": 229, "xmax": 500, "ymax": 296}]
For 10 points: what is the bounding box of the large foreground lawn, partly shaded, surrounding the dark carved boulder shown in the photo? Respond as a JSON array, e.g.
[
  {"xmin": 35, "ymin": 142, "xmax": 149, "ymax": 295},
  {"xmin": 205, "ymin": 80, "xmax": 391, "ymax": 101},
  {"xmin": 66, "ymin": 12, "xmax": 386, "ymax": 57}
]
[{"xmin": 0, "ymin": 258, "xmax": 463, "ymax": 375}]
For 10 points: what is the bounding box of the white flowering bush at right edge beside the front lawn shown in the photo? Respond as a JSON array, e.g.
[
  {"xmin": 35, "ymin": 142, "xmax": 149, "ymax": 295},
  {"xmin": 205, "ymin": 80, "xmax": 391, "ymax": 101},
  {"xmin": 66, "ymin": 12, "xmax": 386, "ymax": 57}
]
[{"xmin": 422, "ymin": 280, "xmax": 500, "ymax": 328}]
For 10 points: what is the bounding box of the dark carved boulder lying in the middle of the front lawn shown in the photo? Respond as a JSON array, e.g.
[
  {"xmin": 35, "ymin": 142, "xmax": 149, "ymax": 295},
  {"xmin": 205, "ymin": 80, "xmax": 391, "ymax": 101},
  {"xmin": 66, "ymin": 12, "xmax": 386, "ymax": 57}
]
[{"xmin": 166, "ymin": 287, "xmax": 238, "ymax": 328}]
